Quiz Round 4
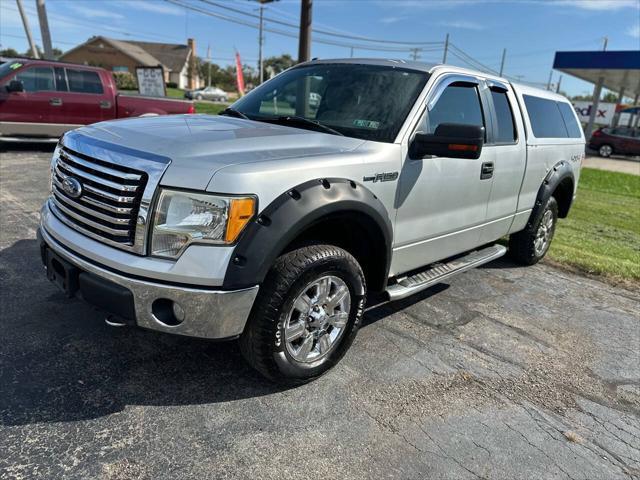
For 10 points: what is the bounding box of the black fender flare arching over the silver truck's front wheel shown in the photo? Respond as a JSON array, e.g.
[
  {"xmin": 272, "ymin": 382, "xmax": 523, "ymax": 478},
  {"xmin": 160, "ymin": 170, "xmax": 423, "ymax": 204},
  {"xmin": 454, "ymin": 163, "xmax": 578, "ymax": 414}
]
[{"xmin": 223, "ymin": 178, "xmax": 393, "ymax": 289}]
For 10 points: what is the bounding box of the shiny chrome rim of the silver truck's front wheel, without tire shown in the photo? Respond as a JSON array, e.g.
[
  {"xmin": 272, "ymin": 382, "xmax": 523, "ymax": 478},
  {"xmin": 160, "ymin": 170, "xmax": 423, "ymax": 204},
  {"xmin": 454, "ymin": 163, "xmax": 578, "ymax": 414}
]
[{"xmin": 284, "ymin": 275, "xmax": 351, "ymax": 363}]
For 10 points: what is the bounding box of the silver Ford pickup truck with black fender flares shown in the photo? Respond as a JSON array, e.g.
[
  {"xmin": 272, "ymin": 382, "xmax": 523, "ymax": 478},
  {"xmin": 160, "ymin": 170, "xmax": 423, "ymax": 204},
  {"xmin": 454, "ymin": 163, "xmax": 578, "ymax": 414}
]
[{"xmin": 39, "ymin": 59, "xmax": 585, "ymax": 383}]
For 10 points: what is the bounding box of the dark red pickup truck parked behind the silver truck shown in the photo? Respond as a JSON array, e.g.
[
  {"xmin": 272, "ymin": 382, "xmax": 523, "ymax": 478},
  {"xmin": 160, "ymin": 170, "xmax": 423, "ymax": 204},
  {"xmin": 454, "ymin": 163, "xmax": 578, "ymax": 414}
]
[{"xmin": 0, "ymin": 59, "xmax": 194, "ymax": 141}]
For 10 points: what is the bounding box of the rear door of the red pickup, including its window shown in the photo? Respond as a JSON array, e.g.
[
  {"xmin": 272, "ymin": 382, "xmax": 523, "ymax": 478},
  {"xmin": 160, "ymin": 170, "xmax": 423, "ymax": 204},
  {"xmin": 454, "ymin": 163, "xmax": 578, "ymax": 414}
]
[{"xmin": 56, "ymin": 67, "xmax": 115, "ymax": 125}]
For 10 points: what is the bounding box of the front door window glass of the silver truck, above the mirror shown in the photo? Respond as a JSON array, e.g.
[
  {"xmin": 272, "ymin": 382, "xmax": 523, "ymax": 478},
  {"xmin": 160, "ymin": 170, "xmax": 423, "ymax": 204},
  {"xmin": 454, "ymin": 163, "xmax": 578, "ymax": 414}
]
[{"xmin": 428, "ymin": 85, "xmax": 484, "ymax": 133}]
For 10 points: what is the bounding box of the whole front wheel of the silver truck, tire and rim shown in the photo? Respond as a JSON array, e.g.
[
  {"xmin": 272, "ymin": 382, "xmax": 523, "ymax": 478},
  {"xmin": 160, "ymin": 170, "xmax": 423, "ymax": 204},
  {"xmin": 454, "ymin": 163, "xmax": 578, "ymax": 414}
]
[{"xmin": 240, "ymin": 245, "xmax": 366, "ymax": 383}]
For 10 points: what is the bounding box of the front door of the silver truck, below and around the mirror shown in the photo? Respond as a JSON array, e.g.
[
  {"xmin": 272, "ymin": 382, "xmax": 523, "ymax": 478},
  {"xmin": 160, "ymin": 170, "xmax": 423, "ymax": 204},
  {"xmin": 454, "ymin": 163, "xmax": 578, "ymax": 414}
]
[{"xmin": 391, "ymin": 74, "xmax": 493, "ymax": 275}]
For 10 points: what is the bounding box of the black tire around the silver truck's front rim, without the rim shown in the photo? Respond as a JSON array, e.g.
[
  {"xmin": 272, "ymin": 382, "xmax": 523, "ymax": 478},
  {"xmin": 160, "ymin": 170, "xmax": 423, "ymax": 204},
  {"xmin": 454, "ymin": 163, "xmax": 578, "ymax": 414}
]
[{"xmin": 240, "ymin": 245, "xmax": 366, "ymax": 384}]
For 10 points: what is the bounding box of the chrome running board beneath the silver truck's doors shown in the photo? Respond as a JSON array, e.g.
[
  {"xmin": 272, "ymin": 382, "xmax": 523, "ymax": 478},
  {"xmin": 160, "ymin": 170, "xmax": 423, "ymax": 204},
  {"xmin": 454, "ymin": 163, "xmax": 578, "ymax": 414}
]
[{"xmin": 387, "ymin": 245, "xmax": 507, "ymax": 300}]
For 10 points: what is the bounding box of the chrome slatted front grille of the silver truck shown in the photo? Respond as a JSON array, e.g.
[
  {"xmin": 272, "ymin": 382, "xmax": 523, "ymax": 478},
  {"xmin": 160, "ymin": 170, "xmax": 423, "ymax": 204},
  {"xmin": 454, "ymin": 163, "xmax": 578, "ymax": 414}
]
[{"xmin": 51, "ymin": 147, "xmax": 148, "ymax": 250}]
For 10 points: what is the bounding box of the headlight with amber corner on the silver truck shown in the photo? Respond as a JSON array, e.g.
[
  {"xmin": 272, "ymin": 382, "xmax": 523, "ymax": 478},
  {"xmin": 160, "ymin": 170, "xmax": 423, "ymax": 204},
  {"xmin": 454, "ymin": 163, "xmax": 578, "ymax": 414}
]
[{"xmin": 151, "ymin": 189, "xmax": 256, "ymax": 258}]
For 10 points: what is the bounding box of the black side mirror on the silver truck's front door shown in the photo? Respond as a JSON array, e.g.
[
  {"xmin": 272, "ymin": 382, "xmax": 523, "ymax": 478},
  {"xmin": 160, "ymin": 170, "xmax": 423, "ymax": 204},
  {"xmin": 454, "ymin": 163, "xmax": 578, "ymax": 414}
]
[{"xmin": 409, "ymin": 123, "xmax": 484, "ymax": 160}]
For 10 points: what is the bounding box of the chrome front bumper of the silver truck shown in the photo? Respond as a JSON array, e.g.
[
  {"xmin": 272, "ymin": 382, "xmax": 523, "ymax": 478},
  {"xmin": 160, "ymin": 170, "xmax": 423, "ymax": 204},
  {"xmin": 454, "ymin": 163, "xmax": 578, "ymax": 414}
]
[{"xmin": 38, "ymin": 228, "xmax": 258, "ymax": 339}]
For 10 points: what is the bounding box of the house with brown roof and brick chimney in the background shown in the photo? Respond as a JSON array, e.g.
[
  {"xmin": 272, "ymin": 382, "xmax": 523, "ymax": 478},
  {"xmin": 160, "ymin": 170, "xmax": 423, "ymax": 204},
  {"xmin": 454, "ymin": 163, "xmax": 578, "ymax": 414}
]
[{"xmin": 59, "ymin": 36, "xmax": 200, "ymax": 89}]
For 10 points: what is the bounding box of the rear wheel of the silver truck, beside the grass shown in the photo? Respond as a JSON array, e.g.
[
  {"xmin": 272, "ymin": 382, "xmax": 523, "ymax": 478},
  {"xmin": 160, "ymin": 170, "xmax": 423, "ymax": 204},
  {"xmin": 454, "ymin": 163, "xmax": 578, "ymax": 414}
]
[{"xmin": 509, "ymin": 197, "xmax": 558, "ymax": 265}]
